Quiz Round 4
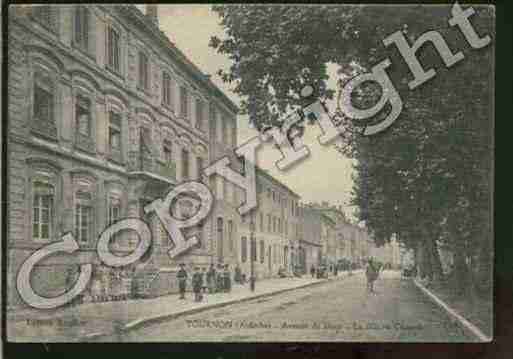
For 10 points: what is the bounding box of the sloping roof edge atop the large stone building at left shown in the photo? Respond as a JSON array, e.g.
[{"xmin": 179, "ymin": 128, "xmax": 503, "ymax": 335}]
[{"xmin": 122, "ymin": 5, "xmax": 239, "ymax": 113}]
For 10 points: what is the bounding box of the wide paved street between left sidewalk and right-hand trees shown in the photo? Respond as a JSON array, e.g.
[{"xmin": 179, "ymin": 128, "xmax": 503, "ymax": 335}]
[{"xmin": 99, "ymin": 271, "xmax": 475, "ymax": 342}]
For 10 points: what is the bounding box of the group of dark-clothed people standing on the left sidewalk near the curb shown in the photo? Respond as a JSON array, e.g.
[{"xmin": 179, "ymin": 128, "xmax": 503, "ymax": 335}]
[{"xmin": 177, "ymin": 263, "xmax": 244, "ymax": 302}]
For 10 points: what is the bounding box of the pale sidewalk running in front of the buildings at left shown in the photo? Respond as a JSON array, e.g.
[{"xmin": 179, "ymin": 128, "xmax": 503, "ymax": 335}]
[{"xmin": 7, "ymin": 271, "xmax": 359, "ymax": 342}]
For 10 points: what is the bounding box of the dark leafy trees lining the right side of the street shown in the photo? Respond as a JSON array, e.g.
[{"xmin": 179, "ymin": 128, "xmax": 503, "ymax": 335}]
[{"xmin": 211, "ymin": 5, "xmax": 495, "ymax": 293}]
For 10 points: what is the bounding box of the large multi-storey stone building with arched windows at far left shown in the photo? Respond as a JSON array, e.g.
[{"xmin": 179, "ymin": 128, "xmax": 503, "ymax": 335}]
[{"xmin": 6, "ymin": 5, "xmax": 237, "ymax": 306}]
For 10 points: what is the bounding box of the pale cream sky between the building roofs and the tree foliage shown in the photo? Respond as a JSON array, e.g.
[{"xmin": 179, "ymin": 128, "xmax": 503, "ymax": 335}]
[{"xmin": 137, "ymin": 4, "xmax": 354, "ymax": 217}]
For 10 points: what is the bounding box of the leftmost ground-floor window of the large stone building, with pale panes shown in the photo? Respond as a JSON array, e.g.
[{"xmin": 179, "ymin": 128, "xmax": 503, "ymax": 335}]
[{"xmin": 32, "ymin": 182, "xmax": 55, "ymax": 241}]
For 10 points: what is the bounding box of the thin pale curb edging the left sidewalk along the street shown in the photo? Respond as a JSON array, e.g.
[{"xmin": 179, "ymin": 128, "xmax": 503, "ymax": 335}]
[{"xmin": 79, "ymin": 273, "xmax": 357, "ymax": 341}]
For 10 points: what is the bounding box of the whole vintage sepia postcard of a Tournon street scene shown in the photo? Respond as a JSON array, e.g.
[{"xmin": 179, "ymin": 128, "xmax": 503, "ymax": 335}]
[{"xmin": 2, "ymin": 2, "xmax": 495, "ymax": 343}]
